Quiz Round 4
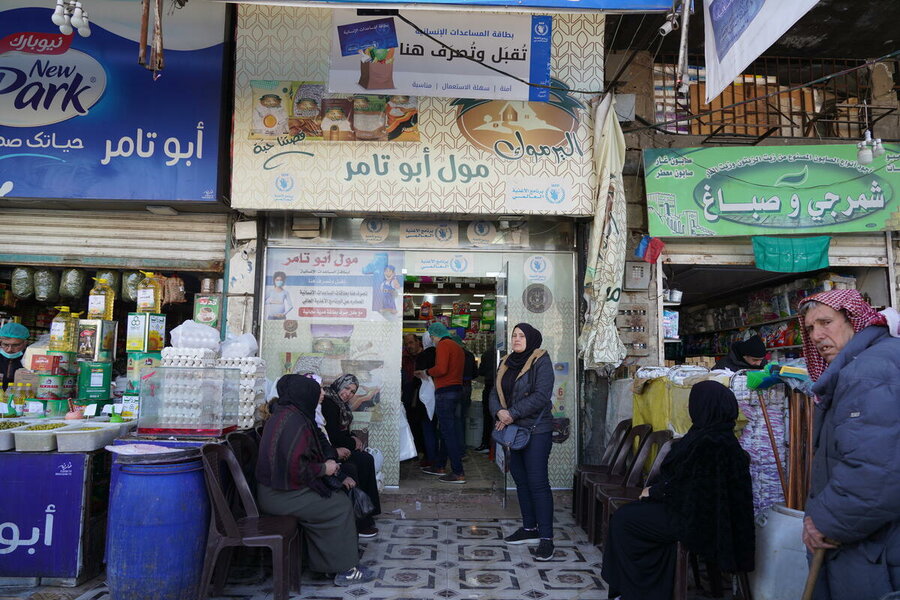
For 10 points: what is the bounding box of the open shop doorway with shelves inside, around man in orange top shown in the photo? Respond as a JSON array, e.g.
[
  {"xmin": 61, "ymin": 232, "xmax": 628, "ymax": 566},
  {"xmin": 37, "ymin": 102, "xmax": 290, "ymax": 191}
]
[{"xmin": 400, "ymin": 270, "xmax": 506, "ymax": 503}]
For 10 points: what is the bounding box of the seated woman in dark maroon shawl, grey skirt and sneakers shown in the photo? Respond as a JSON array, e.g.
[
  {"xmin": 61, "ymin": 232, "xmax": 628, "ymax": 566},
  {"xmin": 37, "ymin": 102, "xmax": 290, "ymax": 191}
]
[{"xmin": 256, "ymin": 375, "xmax": 374, "ymax": 586}]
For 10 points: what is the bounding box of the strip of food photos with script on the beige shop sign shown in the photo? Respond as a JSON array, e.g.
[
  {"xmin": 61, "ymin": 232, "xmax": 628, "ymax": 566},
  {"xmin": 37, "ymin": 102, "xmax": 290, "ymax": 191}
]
[{"xmin": 250, "ymin": 81, "xmax": 419, "ymax": 142}]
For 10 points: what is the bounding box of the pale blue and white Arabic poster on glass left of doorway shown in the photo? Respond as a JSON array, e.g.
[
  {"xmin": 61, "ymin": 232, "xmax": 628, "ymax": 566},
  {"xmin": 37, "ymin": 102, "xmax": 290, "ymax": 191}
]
[{"xmin": 264, "ymin": 249, "xmax": 403, "ymax": 321}]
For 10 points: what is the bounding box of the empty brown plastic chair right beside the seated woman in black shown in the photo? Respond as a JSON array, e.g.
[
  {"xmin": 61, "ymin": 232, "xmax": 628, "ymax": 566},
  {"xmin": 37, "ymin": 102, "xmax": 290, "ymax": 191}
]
[{"xmin": 588, "ymin": 429, "xmax": 673, "ymax": 548}]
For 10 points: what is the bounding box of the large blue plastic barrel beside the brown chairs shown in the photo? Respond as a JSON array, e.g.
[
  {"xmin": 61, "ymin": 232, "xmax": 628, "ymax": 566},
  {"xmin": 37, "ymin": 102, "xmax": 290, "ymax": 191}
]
[{"xmin": 106, "ymin": 458, "xmax": 209, "ymax": 600}]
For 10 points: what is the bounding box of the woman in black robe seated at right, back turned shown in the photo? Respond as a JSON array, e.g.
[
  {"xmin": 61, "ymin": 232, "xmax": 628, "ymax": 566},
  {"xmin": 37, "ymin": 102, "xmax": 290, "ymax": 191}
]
[{"xmin": 602, "ymin": 381, "xmax": 756, "ymax": 600}]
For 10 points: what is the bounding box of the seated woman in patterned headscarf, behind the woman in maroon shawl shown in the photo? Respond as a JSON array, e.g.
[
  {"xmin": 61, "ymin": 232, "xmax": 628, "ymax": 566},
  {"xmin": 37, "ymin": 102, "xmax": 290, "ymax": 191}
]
[{"xmin": 322, "ymin": 373, "xmax": 381, "ymax": 537}]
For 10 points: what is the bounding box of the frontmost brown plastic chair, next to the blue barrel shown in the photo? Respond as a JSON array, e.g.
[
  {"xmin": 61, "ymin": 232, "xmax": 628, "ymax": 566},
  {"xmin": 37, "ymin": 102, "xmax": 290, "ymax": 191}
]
[{"xmin": 199, "ymin": 444, "xmax": 301, "ymax": 600}]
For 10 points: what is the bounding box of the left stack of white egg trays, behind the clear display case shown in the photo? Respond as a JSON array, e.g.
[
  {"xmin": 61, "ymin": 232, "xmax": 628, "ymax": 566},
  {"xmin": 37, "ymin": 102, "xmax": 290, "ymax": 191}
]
[{"xmin": 159, "ymin": 348, "xmax": 221, "ymax": 428}]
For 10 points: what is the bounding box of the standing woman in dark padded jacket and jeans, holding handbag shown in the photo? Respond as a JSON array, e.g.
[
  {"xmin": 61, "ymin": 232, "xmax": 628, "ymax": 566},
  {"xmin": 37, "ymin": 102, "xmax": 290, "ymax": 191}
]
[{"xmin": 490, "ymin": 323, "xmax": 554, "ymax": 561}]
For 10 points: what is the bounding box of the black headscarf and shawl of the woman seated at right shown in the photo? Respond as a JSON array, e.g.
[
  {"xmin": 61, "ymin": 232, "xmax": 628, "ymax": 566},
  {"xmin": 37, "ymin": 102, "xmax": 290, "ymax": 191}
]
[{"xmin": 650, "ymin": 381, "xmax": 755, "ymax": 572}]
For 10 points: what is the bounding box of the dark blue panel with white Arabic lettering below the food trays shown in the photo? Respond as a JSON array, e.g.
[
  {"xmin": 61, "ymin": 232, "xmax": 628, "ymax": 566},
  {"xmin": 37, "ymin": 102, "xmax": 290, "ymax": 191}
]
[{"xmin": 0, "ymin": 452, "xmax": 87, "ymax": 577}]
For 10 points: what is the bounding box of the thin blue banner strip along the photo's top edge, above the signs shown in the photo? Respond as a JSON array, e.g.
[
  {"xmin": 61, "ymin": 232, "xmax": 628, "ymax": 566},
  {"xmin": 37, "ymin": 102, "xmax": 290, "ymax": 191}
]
[{"xmin": 218, "ymin": 0, "xmax": 672, "ymax": 13}]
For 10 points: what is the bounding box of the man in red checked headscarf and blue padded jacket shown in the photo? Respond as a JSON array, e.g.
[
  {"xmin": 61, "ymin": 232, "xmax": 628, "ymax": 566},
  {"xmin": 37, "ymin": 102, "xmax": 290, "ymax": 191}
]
[{"xmin": 799, "ymin": 290, "xmax": 900, "ymax": 600}]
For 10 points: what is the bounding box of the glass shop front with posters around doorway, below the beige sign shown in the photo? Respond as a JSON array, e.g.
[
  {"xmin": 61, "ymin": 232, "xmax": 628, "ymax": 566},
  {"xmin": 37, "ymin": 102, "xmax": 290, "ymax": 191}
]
[{"xmin": 260, "ymin": 217, "xmax": 578, "ymax": 487}]
